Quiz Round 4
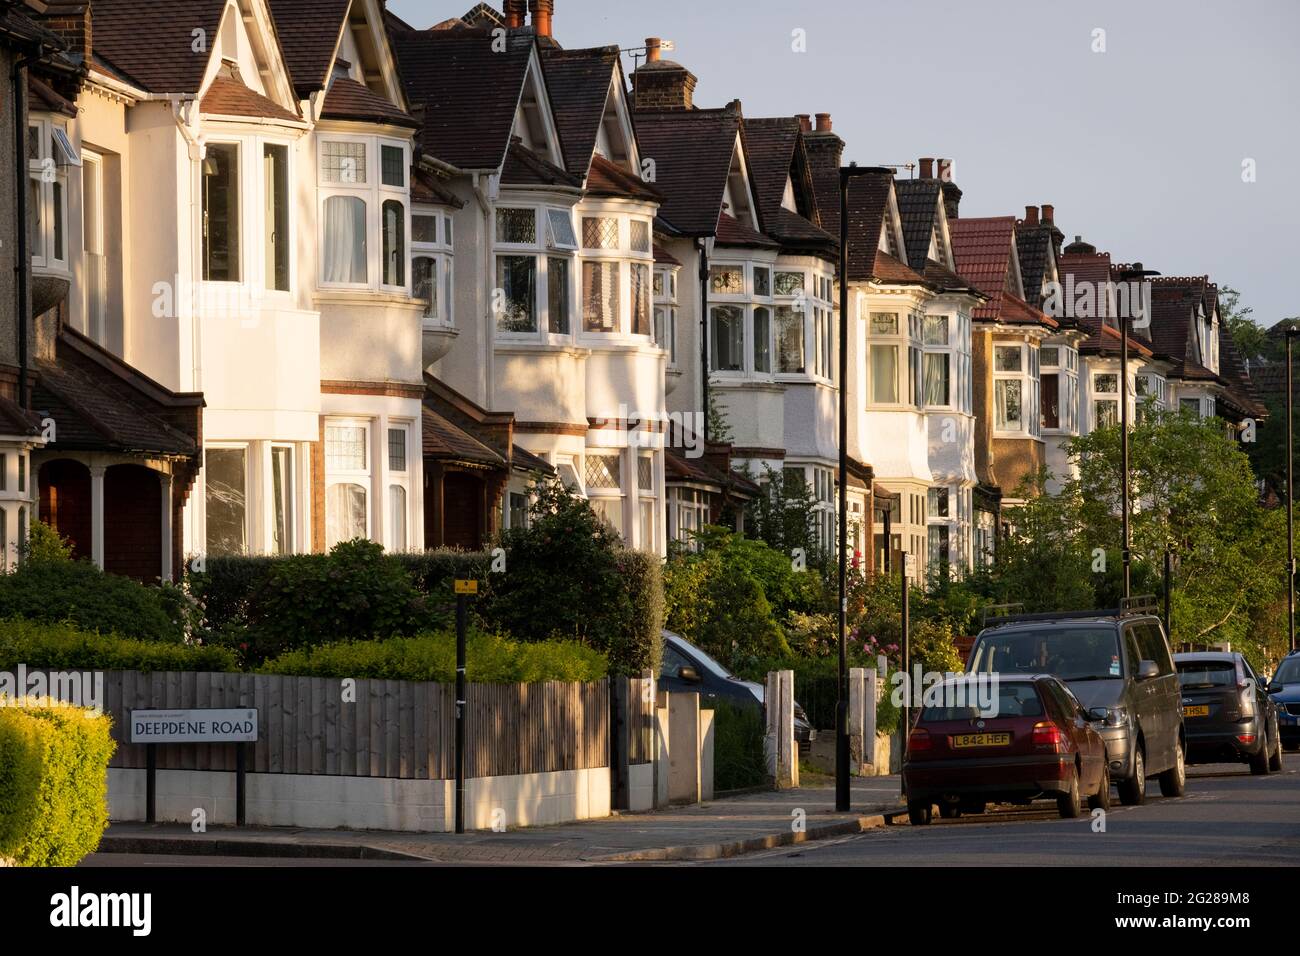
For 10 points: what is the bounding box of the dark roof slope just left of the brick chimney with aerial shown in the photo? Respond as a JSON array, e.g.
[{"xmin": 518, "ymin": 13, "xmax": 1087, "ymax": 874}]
[{"xmin": 541, "ymin": 46, "xmax": 621, "ymax": 176}]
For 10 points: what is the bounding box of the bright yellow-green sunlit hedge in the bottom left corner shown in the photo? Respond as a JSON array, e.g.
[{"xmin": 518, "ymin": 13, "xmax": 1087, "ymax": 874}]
[{"xmin": 0, "ymin": 701, "xmax": 114, "ymax": 866}]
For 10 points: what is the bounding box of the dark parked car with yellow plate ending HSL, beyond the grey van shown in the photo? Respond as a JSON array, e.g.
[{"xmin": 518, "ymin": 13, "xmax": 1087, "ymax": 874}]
[{"xmin": 1174, "ymin": 652, "xmax": 1282, "ymax": 774}]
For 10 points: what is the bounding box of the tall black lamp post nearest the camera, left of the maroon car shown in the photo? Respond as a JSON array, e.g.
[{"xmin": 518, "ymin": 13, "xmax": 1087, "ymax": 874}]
[{"xmin": 835, "ymin": 163, "xmax": 893, "ymax": 813}]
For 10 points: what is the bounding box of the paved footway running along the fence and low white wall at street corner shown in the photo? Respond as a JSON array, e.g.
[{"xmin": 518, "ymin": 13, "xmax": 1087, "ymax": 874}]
[{"xmin": 94, "ymin": 777, "xmax": 905, "ymax": 866}]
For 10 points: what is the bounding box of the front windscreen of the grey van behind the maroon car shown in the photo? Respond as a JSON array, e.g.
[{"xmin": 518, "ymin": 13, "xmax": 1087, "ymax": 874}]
[{"xmin": 970, "ymin": 624, "xmax": 1123, "ymax": 680}]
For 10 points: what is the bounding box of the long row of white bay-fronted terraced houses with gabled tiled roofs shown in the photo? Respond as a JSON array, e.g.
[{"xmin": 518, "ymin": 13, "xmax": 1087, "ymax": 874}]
[{"xmin": 0, "ymin": 0, "xmax": 1262, "ymax": 579}]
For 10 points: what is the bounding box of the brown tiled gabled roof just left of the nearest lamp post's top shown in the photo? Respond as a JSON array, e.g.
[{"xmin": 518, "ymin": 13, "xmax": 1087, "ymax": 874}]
[{"xmin": 744, "ymin": 116, "xmax": 840, "ymax": 254}]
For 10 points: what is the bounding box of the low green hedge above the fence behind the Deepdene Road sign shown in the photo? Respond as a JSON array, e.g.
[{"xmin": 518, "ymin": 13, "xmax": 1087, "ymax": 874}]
[{"xmin": 0, "ymin": 619, "xmax": 238, "ymax": 672}]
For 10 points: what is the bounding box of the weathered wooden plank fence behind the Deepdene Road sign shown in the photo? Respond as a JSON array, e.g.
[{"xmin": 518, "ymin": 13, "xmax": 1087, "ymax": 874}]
[{"xmin": 74, "ymin": 671, "xmax": 610, "ymax": 780}]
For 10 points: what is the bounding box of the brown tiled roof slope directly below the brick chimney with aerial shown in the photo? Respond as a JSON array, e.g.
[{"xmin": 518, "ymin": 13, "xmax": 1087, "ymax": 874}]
[{"xmin": 633, "ymin": 108, "xmax": 740, "ymax": 235}]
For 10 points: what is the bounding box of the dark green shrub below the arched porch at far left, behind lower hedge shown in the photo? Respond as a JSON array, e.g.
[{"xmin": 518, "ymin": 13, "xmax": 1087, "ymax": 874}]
[{"xmin": 0, "ymin": 553, "xmax": 185, "ymax": 643}]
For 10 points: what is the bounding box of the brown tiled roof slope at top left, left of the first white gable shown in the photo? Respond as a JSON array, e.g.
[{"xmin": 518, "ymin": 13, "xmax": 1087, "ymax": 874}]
[{"xmin": 91, "ymin": 0, "xmax": 226, "ymax": 92}]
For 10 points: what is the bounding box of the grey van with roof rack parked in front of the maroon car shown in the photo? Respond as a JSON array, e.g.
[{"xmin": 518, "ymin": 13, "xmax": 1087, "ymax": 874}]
[{"xmin": 967, "ymin": 610, "xmax": 1187, "ymax": 804}]
